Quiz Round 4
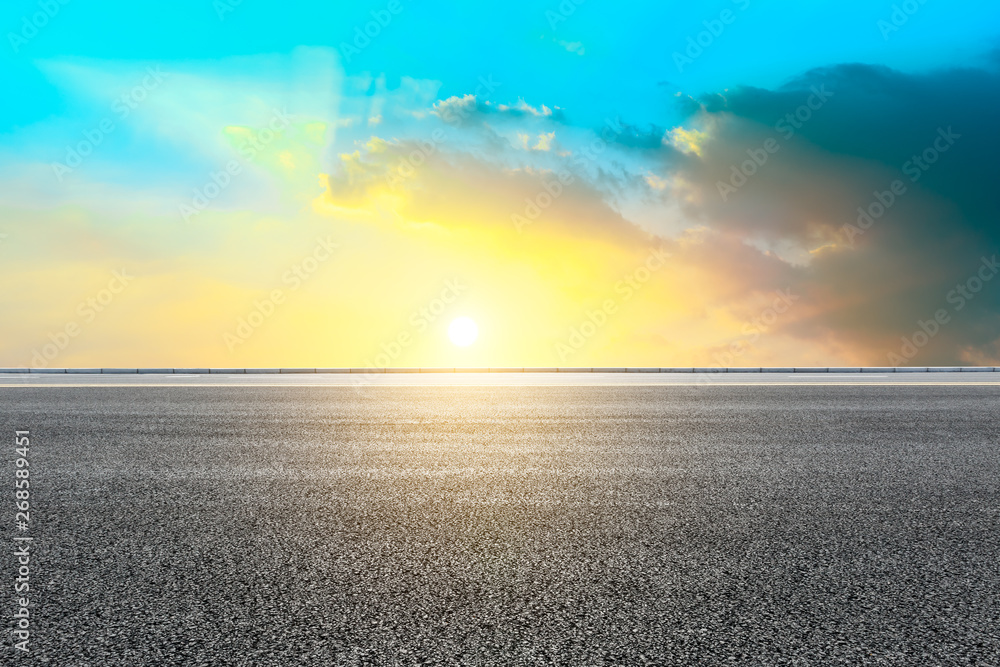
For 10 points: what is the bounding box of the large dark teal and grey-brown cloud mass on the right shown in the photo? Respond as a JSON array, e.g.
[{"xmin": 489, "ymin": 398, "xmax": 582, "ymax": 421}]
[{"xmin": 665, "ymin": 56, "xmax": 1000, "ymax": 365}]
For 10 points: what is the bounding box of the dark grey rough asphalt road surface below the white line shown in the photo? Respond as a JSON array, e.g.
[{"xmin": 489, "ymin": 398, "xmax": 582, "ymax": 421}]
[{"xmin": 0, "ymin": 384, "xmax": 1000, "ymax": 667}]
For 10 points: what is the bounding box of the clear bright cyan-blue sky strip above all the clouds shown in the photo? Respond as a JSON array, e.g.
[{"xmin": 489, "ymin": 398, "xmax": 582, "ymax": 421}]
[{"xmin": 0, "ymin": 0, "xmax": 1000, "ymax": 132}]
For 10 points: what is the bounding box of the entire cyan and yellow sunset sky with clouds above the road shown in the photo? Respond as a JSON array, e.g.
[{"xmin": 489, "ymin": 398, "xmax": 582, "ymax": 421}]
[{"xmin": 0, "ymin": 0, "xmax": 1000, "ymax": 368}]
